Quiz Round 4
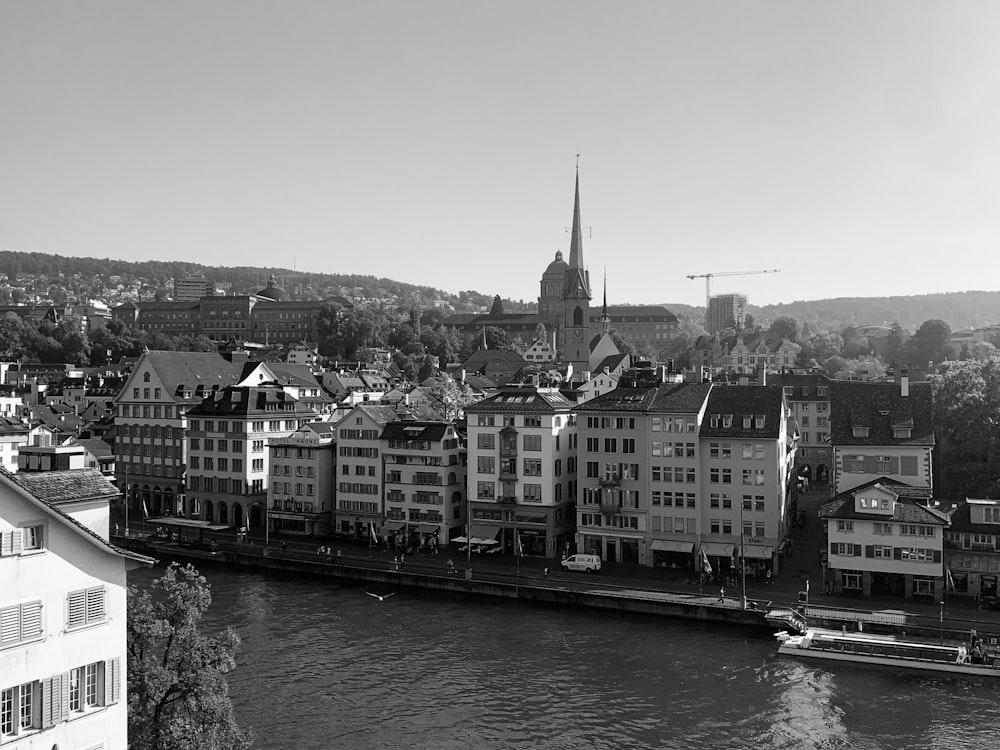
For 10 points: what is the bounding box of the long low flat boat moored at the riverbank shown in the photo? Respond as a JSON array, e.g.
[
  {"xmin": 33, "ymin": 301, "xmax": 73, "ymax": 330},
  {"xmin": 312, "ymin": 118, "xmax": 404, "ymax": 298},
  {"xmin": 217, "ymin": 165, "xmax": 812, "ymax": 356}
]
[{"xmin": 775, "ymin": 627, "xmax": 1000, "ymax": 677}]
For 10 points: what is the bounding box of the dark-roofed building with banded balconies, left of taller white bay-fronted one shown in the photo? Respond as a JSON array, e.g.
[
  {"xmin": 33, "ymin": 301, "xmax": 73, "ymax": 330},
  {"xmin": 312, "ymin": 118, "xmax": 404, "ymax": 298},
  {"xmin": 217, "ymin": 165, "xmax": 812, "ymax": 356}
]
[{"xmin": 380, "ymin": 420, "xmax": 468, "ymax": 550}]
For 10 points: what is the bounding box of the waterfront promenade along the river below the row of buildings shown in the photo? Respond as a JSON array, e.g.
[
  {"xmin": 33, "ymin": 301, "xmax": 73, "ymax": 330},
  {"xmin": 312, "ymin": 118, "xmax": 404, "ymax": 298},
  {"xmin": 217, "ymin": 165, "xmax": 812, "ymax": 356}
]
[{"xmin": 119, "ymin": 490, "xmax": 1000, "ymax": 638}]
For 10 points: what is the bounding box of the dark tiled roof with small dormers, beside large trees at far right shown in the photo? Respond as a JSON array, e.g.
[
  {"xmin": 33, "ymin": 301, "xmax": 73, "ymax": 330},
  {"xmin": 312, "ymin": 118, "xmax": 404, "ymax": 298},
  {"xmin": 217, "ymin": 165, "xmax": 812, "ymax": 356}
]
[{"xmin": 830, "ymin": 380, "xmax": 934, "ymax": 445}]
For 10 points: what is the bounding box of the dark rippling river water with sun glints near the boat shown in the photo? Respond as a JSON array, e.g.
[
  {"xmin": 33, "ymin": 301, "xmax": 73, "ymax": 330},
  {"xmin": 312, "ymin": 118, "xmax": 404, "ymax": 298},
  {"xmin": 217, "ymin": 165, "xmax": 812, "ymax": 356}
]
[{"xmin": 129, "ymin": 566, "xmax": 1000, "ymax": 750}]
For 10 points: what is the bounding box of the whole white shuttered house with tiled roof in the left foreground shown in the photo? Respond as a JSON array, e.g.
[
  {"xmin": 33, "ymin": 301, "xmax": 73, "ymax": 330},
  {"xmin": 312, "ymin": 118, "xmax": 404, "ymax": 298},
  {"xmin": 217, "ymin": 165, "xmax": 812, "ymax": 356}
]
[{"xmin": 0, "ymin": 470, "xmax": 154, "ymax": 750}]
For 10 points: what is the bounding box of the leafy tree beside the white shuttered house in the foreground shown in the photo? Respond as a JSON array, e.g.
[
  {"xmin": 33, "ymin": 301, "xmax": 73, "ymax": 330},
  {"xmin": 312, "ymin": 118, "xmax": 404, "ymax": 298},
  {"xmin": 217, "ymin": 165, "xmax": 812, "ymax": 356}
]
[{"xmin": 128, "ymin": 563, "xmax": 253, "ymax": 750}]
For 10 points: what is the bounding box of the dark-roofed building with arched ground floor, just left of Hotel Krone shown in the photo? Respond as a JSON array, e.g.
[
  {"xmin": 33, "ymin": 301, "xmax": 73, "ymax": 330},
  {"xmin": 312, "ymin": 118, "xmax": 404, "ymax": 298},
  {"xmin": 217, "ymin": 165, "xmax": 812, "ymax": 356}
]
[{"xmin": 186, "ymin": 383, "xmax": 316, "ymax": 529}]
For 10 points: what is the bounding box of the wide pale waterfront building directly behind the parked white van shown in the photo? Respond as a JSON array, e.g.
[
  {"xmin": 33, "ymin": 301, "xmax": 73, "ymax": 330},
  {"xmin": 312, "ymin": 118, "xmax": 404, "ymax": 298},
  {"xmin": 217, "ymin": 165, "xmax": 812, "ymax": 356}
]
[{"xmin": 576, "ymin": 369, "xmax": 712, "ymax": 567}]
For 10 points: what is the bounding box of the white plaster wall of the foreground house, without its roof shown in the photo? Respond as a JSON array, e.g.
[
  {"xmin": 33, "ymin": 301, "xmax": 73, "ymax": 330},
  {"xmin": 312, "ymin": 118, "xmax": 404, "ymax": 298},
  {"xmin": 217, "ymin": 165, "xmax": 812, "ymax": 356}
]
[{"xmin": 0, "ymin": 482, "xmax": 133, "ymax": 750}]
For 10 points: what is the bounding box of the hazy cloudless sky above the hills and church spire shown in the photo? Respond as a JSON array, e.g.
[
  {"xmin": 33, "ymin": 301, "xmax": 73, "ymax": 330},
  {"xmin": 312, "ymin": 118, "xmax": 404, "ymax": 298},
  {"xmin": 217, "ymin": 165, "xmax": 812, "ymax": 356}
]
[{"xmin": 0, "ymin": 0, "xmax": 1000, "ymax": 304}]
